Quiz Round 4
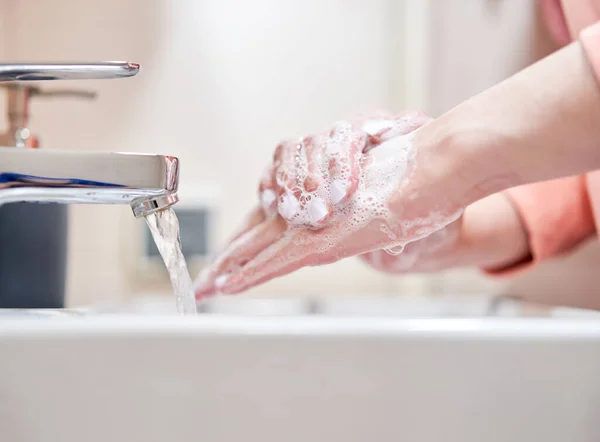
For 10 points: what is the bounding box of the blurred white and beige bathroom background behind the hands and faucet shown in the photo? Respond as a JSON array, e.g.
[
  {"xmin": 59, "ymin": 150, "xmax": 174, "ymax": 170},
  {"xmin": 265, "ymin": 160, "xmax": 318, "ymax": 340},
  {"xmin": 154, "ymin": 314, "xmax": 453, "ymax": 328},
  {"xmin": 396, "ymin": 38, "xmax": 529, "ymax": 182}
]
[{"xmin": 0, "ymin": 0, "xmax": 600, "ymax": 307}]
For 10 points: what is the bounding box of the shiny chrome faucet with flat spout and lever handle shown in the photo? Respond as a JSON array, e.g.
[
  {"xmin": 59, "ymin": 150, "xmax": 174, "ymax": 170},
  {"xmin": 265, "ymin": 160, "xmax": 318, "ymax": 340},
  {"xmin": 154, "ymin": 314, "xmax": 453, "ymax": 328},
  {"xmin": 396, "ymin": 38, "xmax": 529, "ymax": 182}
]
[{"xmin": 0, "ymin": 62, "xmax": 179, "ymax": 218}]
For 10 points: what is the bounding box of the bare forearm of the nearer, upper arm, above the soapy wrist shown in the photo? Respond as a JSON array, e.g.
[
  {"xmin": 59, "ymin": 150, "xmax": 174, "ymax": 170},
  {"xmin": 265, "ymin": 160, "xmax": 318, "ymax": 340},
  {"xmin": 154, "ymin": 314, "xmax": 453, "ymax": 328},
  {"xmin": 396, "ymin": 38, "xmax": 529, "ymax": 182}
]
[{"xmin": 415, "ymin": 43, "xmax": 600, "ymax": 205}]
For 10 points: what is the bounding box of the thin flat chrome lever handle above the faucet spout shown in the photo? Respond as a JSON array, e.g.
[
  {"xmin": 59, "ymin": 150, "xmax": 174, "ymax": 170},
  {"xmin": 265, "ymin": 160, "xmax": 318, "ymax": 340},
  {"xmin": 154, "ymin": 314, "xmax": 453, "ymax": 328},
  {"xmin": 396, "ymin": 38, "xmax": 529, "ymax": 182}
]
[{"xmin": 0, "ymin": 62, "xmax": 140, "ymax": 82}]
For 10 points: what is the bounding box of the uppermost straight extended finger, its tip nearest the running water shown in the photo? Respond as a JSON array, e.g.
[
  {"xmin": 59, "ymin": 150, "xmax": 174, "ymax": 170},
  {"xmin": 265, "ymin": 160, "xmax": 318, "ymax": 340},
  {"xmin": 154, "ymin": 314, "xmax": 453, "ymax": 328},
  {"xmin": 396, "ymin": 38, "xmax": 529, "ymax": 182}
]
[{"xmin": 195, "ymin": 217, "xmax": 287, "ymax": 296}]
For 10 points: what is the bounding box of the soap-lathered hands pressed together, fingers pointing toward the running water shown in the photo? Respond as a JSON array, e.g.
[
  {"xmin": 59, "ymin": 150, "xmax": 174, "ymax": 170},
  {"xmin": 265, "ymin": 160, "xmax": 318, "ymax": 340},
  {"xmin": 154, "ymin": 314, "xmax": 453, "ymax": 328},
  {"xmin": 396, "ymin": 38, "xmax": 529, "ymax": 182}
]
[{"xmin": 196, "ymin": 112, "xmax": 462, "ymax": 298}]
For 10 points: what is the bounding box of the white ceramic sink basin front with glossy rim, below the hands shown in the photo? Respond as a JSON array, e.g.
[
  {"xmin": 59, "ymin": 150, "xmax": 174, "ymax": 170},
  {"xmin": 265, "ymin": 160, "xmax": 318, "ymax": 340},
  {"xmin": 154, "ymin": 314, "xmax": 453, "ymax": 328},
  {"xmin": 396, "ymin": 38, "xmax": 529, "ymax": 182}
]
[{"xmin": 0, "ymin": 314, "xmax": 600, "ymax": 442}]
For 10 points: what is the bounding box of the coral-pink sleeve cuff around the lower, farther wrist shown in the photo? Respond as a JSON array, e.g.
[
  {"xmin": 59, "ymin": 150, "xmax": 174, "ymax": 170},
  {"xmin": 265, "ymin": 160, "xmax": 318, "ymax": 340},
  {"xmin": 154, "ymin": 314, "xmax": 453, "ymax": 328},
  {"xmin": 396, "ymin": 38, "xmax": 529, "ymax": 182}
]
[{"xmin": 486, "ymin": 176, "xmax": 595, "ymax": 275}]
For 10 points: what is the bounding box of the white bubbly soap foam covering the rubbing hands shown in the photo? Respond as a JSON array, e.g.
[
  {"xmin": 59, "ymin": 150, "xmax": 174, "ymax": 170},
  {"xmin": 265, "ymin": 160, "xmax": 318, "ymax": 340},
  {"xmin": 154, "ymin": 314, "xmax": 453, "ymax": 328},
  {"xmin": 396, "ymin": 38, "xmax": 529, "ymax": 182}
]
[{"xmin": 262, "ymin": 113, "xmax": 462, "ymax": 266}]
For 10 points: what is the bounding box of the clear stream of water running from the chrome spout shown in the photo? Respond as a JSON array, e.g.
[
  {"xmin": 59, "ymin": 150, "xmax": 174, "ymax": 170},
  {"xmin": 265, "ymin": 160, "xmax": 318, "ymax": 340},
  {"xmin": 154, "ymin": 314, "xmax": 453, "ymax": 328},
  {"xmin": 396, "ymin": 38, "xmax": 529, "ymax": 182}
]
[{"xmin": 146, "ymin": 208, "xmax": 197, "ymax": 315}]
